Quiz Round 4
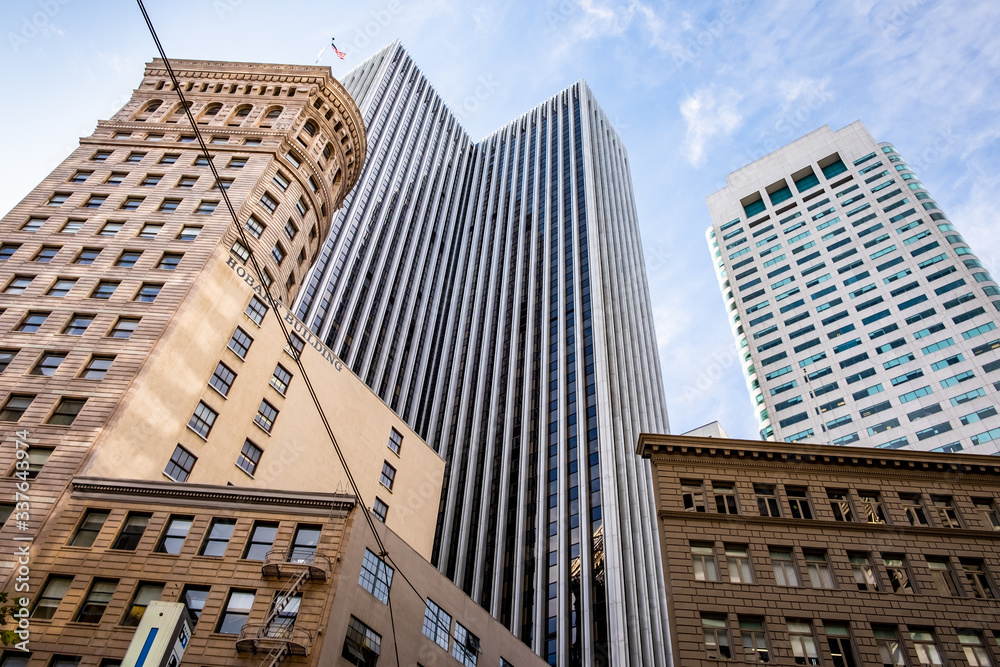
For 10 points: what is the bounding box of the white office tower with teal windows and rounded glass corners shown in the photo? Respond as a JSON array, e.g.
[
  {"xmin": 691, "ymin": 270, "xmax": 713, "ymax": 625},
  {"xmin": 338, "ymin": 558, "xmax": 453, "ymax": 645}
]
[{"xmin": 708, "ymin": 122, "xmax": 1000, "ymax": 454}]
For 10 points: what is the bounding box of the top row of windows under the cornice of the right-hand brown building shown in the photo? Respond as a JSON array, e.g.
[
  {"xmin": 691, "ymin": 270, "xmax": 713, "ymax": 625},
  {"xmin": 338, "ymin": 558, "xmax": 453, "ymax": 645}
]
[{"xmin": 681, "ymin": 480, "xmax": 1000, "ymax": 530}]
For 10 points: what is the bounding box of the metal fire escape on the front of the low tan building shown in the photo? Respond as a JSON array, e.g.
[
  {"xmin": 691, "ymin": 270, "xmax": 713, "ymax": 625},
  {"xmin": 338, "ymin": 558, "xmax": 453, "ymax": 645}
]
[{"xmin": 236, "ymin": 548, "xmax": 330, "ymax": 667}]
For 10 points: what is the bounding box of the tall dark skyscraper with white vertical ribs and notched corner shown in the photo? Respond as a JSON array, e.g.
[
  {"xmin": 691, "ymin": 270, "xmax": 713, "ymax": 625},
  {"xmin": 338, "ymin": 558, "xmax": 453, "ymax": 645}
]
[{"xmin": 296, "ymin": 43, "xmax": 667, "ymax": 665}]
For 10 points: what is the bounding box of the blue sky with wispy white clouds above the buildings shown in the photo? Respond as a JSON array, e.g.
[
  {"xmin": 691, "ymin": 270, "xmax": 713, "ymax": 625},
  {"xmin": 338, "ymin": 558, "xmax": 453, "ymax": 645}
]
[{"xmin": 0, "ymin": 0, "xmax": 1000, "ymax": 438}]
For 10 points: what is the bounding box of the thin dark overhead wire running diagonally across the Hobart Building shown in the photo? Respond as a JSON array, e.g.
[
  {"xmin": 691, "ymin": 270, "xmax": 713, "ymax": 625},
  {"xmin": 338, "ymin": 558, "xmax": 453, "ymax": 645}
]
[{"xmin": 136, "ymin": 0, "xmax": 427, "ymax": 666}]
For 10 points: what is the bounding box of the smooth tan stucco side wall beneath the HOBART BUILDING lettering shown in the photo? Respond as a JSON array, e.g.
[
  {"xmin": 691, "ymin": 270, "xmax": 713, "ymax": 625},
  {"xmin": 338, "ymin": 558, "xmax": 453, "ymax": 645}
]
[{"xmin": 81, "ymin": 248, "xmax": 444, "ymax": 558}]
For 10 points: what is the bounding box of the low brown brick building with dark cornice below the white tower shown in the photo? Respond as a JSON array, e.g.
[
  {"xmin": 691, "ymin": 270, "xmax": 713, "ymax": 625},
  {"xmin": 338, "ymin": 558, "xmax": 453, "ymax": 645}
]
[{"xmin": 638, "ymin": 434, "xmax": 1000, "ymax": 667}]
